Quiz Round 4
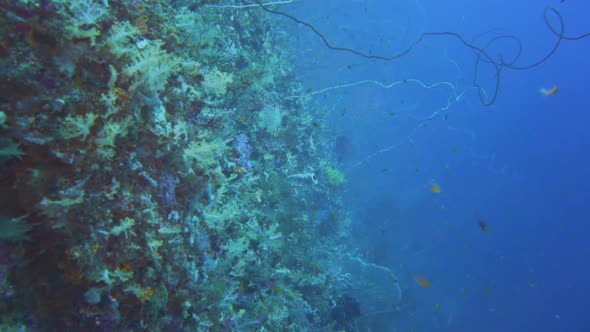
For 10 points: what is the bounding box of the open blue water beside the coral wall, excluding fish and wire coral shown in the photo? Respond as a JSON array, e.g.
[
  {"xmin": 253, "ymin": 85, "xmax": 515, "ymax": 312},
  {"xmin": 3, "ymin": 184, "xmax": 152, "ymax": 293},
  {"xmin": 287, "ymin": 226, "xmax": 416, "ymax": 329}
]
[{"xmin": 292, "ymin": 0, "xmax": 590, "ymax": 331}]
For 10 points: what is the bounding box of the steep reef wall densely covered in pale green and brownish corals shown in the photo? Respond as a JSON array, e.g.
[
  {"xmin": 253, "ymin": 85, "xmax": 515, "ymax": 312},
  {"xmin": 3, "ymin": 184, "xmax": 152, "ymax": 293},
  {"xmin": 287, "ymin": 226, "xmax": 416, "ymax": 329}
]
[{"xmin": 0, "ymin": 0, "xmax": 366, "ymax": 331}]
